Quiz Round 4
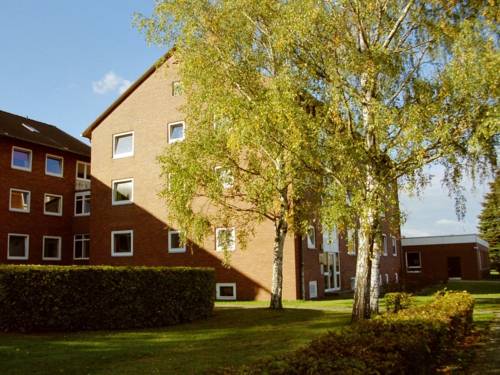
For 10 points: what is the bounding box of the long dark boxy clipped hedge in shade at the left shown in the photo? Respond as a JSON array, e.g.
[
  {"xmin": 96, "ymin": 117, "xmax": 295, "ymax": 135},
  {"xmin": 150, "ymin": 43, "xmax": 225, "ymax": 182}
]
[{"xmin": 0, "ymin": 266, "xmax": 215, "ymax": 332}]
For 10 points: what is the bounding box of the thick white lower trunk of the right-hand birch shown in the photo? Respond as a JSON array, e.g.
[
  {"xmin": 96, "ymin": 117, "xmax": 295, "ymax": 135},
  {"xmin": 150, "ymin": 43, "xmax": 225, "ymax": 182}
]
[{"xmin": 351, "ymin": 226, "xmax": 372, "ymax": 322}]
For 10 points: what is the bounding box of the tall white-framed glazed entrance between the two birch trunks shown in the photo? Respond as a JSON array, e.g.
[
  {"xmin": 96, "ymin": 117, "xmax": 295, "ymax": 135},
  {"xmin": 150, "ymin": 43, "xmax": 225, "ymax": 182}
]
[{"xmin": 321, "ymin": 228, "xmax": 340, "ymax": 292}]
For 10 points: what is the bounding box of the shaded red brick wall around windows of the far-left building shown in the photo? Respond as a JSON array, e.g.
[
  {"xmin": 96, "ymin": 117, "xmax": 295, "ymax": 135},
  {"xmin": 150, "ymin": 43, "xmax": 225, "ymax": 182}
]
[{"xmin": 0, "ymin": 137, "xmax": 89, "ymax": 264}]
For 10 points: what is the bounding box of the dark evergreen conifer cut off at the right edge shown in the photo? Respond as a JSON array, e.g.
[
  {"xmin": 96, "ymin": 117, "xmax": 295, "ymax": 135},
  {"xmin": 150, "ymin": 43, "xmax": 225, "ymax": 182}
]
[{"xmin": 479, "ymin": 172, "xmax": 500, "ymax": 269}]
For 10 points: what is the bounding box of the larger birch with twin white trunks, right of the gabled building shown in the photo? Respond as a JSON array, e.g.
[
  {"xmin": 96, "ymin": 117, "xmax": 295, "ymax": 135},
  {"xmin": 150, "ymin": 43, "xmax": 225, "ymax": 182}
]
[{"xmin": 284, "ymin": 0, "xmax": 500, "ymax": 320}]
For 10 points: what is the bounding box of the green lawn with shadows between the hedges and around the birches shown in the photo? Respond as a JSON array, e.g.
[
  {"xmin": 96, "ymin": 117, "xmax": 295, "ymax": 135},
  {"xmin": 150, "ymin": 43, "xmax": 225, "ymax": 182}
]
[{"xmin": 0, "ymin": 281, "xmax": 500, "ymax": 375}]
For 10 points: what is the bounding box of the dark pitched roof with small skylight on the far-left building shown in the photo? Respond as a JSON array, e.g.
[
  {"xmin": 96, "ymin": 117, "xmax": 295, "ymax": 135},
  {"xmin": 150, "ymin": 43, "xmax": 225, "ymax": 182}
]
[{"xmin": 0, "ymin": 110, "xmax": 90, "ymax": 157}]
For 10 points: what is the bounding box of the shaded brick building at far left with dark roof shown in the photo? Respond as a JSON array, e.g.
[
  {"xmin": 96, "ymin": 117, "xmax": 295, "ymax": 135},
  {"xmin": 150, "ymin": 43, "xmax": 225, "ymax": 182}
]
[{"xmin": 0, "ymin": 111, "xmax": 90, "ymax": 264}]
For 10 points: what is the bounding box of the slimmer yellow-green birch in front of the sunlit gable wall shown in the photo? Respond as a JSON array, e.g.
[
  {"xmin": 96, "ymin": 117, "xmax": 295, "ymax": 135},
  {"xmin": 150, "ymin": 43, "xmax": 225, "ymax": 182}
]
[{"xmin": 140, "ymin": 1, "xmax": 322, "ymax": 309}]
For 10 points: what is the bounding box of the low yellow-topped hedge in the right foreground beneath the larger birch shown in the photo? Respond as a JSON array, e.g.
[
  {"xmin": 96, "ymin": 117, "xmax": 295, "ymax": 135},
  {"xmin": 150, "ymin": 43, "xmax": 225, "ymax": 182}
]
[{"xmin": 215, "ymin": 292, "xmax": 474, "ymax": 375}]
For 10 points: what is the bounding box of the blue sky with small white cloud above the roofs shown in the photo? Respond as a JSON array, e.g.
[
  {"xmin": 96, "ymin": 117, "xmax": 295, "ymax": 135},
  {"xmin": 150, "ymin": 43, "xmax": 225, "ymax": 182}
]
[{"xmin": 0, "ymin": 0, "xmax": 488, "ymax": 237}]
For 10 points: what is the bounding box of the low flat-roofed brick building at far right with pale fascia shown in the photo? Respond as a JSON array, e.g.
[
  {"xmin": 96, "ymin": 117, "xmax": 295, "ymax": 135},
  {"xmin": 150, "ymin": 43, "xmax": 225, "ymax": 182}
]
[{"xmin": 401, "ymin": 234, "xmax": 490, "ymax": 286}]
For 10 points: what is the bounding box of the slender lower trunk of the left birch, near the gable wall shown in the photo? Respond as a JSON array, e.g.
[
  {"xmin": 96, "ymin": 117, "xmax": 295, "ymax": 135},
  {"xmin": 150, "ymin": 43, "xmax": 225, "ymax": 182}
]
[{"xmin": 269, "ymin": 217, "xmax": 288, "ymax": 310}]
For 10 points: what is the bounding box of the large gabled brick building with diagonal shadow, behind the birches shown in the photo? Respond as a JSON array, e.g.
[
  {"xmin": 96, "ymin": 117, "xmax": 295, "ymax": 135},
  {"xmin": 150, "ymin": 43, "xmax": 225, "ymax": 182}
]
[{"xmin": 84, "ymin": 56, "xmax": 401, "ymax": 300}]
